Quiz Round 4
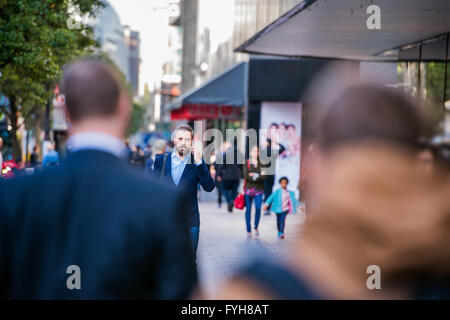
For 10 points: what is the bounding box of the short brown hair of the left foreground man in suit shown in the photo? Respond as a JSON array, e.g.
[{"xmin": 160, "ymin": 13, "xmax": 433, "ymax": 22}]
[{"xmin": 61, "ymin": 58, "xmax": 123, "ymax": 121}]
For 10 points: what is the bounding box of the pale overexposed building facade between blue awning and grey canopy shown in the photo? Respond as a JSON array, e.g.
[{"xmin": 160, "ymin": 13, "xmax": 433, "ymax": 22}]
[{"xmin": 195, "ymin": 0, "xmax": 301, "ymax": 86}]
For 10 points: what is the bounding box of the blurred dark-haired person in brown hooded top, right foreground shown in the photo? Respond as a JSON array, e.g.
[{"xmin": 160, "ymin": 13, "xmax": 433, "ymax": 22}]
[{"xmin": 299, "ymin": 85, "xmax": 450, "ymax": 299}]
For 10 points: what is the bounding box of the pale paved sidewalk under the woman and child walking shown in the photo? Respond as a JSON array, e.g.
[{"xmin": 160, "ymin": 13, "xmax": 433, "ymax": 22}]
[{"xmin": 197, "ymin": 199, "xmax": 304, "ymax": 297}]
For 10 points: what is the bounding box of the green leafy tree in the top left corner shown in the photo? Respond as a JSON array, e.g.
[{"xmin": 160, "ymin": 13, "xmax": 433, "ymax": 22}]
[{"xmin": 0, "ymin": 0, "xmax": 104, "ymax": 157}]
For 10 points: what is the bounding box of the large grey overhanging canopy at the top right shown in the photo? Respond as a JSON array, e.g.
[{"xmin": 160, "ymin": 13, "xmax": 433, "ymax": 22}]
[{"xmin": 236, "ymin": 0, "xmax": 450, "ymax": 61}]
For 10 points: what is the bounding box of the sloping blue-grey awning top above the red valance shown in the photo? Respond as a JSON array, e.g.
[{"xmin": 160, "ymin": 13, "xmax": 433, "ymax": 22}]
[{"xmin": 166, "ymin": 62, "xmax": 246, "ymax": 110}]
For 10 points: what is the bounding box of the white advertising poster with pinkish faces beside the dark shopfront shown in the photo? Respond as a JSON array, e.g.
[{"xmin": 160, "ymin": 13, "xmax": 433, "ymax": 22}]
[{"xmin": 260, "ymin": 102, "xmax": 302, "ymax": 197}]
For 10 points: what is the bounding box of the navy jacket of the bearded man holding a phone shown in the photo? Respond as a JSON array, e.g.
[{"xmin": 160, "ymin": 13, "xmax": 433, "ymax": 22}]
[{"xmin": 152, "ymin": 153, "xmax": 215, "ymax": 227}]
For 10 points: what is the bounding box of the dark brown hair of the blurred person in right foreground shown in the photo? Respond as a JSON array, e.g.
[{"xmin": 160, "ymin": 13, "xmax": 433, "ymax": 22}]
[{"xmin": 320, "ymin": 85, "xmax": 423, "ymax": 151}]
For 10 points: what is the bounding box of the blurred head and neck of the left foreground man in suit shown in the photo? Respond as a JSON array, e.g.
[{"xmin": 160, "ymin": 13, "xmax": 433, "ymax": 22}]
[{"xmin": 61, "ymin": 59, "xmax": 131, "ymax": 137}]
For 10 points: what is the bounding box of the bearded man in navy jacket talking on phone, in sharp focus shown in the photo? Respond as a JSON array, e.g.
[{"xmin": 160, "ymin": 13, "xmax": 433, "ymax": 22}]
[{"xmin": 153, "ymin": 124, "xmax": 215, "ymax": 258}]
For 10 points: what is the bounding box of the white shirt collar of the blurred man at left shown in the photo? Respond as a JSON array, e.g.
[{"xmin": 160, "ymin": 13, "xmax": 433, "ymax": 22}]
[{"xmin": 67, "ymin": 131, "xmax": 125, "ymax": 157}]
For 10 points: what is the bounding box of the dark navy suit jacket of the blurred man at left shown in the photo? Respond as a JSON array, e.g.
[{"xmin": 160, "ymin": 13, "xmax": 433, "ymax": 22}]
[{"xmin": 0, "ymin": 150, "xmax": 196, "ymax": 299}]
